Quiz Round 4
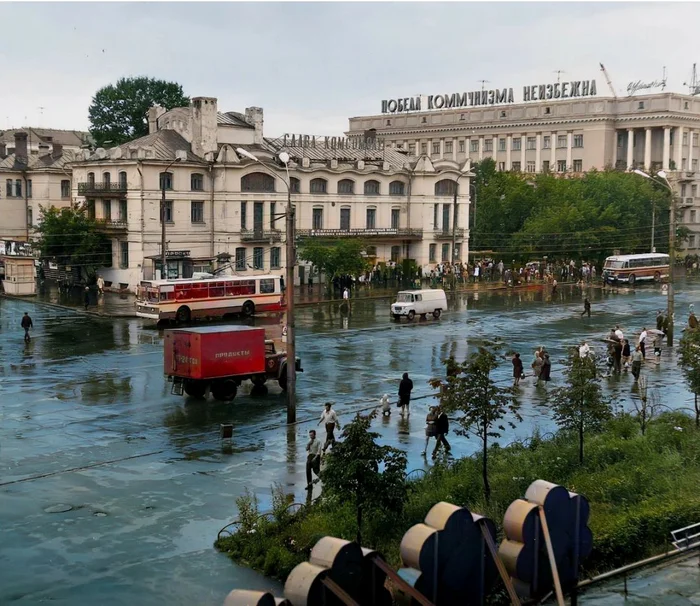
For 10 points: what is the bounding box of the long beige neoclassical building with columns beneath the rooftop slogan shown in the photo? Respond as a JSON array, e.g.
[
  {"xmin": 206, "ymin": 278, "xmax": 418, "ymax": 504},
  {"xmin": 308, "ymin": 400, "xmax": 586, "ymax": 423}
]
[{"xmin": 347, "ymin": 87, "xmax": 700, "ymax": 252}]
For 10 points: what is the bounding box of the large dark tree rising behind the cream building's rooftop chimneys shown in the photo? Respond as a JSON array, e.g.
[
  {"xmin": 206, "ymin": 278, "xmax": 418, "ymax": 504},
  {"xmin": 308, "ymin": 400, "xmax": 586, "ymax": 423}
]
[{"xmin": 88, "ymin": 77, "xmax": 190, "ymax": 146}]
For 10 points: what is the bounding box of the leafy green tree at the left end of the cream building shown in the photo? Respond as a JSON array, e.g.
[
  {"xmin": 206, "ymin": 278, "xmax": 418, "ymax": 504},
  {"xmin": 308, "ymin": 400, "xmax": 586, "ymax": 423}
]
[{"xmin": 36, "ymin": 206, "xmax": 112, "ymax": 276}]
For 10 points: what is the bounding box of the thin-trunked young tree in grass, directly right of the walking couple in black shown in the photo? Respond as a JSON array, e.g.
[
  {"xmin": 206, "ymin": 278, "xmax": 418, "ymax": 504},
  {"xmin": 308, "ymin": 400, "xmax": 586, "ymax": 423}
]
[{"xmin": 429, "ymin": 343, "xmax": 522, "ymax": 501}]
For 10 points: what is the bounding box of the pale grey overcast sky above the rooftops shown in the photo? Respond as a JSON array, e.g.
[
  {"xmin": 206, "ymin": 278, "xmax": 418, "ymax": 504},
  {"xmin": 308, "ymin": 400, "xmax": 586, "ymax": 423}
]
[{"xmin": 0, "ymin": 2, "xmax": 700, "ymax": 136}]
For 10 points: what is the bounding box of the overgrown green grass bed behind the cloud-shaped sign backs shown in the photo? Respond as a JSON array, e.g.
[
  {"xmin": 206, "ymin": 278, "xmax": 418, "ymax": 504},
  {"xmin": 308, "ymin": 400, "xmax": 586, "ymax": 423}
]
[{"xmin": 216, "ymin": 413, "xmax": 700, "ymax": 580}]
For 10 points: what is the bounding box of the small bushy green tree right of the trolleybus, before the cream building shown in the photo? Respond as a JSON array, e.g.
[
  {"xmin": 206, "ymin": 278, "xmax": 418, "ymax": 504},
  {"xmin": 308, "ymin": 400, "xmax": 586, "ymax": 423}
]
[{"xmin": 299, "ymin": 238, "xmax": 369, "ymax": 285}]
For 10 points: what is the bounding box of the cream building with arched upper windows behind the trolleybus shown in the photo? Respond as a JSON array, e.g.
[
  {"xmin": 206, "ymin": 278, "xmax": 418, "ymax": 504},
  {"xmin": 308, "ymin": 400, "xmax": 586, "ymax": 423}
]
[{"xmin": 72, "ymin": 97, "xmax": 469, "ymax": 290}]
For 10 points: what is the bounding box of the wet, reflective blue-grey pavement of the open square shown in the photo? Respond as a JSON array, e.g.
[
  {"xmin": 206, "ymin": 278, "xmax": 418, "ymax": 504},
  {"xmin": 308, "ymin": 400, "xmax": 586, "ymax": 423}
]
[{"xmin": 0, "ymin": 281, "xmax": 700, "ymax": 605}]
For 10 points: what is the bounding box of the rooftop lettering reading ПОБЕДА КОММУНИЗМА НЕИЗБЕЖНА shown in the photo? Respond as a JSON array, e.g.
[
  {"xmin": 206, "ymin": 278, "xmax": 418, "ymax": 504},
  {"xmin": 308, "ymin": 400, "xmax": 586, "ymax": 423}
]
[{"xmin": 382, "ymin": 80, "xmax": 598, "ymax": 114}]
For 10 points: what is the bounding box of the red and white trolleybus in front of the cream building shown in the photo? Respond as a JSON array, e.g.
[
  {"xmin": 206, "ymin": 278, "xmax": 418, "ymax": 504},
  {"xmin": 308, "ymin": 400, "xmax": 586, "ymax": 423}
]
[{"xmin": 136, "ymin": 274, "xmax": 286, "ymax": 323}]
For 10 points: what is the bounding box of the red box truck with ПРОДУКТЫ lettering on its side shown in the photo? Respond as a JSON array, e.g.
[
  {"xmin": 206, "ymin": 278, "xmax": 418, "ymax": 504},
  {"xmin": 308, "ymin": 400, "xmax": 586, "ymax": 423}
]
[{"xmin": 163, "ymin": 326, "xmax": 302, "ymax": 400}]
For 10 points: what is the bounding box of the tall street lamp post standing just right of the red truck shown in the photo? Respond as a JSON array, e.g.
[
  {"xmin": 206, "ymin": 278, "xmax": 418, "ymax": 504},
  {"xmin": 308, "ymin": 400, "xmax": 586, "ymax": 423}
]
[{"xmin": 236, "ymin": 147, "xmax": 297, "ymax": 423}]
